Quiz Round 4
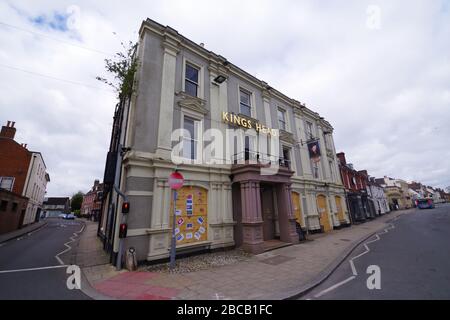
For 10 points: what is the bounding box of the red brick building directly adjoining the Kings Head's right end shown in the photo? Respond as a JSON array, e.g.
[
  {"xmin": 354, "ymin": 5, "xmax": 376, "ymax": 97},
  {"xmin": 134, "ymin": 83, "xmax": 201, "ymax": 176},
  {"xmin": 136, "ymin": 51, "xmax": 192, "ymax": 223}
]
[{"xmin": 336, "ymin": 152, "xmax": 374, "ymax": 222}]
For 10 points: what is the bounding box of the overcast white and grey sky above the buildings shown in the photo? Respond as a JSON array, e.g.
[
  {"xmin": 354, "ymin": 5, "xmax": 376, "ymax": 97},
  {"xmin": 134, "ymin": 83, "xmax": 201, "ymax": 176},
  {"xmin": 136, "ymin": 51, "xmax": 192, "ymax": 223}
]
[{"xmin": 0, "ymin": 0, "xmax": 450, "ymax": 196}]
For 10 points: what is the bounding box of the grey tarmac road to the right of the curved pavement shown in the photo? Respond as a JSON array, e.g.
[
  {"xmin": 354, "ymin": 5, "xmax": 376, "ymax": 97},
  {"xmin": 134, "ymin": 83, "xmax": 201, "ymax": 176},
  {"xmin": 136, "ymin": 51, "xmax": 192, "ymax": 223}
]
[{"xmin": 301, "ymin": 204, "xmax": 450, "ymax": 300}]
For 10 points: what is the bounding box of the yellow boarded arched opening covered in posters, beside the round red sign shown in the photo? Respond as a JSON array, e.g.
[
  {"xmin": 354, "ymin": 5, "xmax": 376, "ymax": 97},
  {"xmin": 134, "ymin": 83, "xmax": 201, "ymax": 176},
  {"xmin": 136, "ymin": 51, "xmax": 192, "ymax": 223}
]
[{"xmin": 170, "ymin": 186, "xmax": 208, "ymax": 245}]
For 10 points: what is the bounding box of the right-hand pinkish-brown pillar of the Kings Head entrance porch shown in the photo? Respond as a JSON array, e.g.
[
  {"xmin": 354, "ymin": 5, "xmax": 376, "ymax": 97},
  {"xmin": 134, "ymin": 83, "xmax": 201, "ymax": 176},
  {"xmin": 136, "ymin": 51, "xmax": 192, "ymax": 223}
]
[{"xmin": 277, "ymin": 183, "xmax": 299, "ymax": 243}]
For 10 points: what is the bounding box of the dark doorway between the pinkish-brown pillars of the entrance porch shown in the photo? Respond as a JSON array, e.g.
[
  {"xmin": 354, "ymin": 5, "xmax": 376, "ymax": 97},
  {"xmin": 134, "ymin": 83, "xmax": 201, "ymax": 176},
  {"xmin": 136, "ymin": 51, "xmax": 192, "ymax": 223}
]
[{"xmin": 260, "ymin": 184, "xmax": 277, "ymax": 241}]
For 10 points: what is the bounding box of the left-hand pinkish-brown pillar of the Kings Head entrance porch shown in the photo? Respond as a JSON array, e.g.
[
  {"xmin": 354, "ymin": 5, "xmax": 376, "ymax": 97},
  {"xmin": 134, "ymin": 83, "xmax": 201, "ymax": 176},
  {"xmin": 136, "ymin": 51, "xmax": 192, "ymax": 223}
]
[{"xmin": 241, "ymin": 181, "xmax": 264, "ymax": 253}]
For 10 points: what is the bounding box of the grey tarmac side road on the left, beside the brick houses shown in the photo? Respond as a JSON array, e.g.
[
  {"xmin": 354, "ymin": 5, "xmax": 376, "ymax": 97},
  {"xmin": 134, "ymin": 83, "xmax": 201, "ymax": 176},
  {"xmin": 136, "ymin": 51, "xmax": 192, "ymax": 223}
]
[{"xmin": 0, "ymin": 218, "xmax": 90, "ymax": 300}]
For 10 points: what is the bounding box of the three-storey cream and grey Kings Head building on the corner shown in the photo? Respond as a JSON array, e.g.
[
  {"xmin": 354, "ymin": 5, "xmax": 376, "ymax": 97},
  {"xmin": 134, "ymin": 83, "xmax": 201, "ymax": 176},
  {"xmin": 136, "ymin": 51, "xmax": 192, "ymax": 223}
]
[{"xmin": 99, "ymin": 19, "xmax": 350, "ymax": 261}]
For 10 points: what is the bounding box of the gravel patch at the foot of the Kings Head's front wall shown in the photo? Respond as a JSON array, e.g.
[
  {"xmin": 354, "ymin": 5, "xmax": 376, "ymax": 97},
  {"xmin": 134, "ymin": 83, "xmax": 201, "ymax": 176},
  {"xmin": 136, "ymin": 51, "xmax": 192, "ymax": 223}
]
[{"xmin": 139, "ymin": 249, "xmax": 252, "ymax": 273}]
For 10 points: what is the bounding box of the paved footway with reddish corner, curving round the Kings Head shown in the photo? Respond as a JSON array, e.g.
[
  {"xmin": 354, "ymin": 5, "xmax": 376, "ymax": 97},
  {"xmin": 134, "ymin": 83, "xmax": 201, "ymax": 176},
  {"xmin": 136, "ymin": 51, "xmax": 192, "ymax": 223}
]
[{"xmin": 77, "ymin": 209, "xmax": 416, "ymax": 300}]
